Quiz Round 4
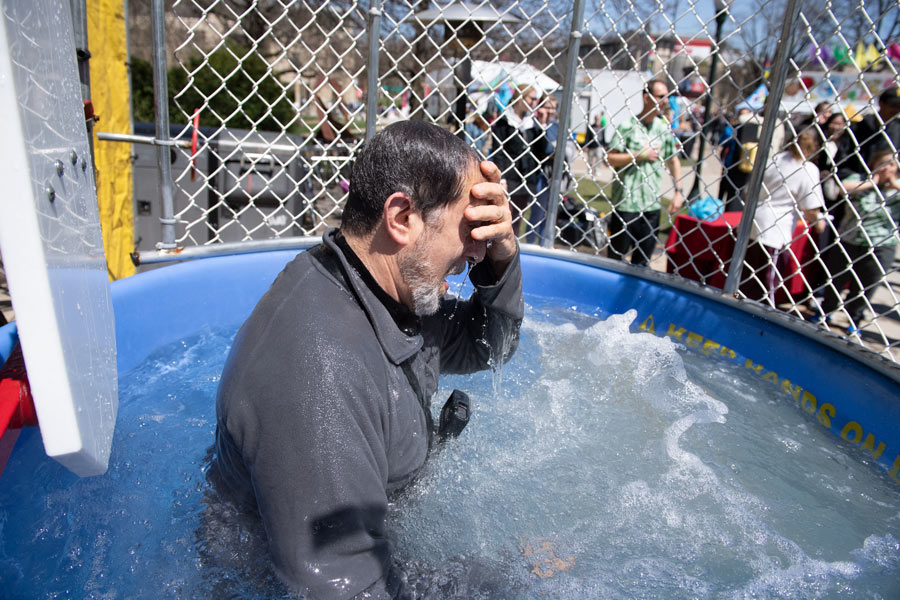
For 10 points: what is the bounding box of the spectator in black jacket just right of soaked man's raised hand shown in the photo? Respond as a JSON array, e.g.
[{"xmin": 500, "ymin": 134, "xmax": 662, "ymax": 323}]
[{"xmin": 490, "ymin": 87, "xmax": 548, "ymax": 236}]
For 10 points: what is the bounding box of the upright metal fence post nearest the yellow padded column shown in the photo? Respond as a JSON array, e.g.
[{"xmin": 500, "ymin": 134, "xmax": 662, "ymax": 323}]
[{"xmin": 150, "ymin": 0, "xmax": 175, "ymax": 250}]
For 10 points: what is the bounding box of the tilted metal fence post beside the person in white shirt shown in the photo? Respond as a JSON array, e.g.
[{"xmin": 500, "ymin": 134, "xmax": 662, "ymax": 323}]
[{"xmin": 723, "ymin": 0, "xmax": 800, "ymax": 296}]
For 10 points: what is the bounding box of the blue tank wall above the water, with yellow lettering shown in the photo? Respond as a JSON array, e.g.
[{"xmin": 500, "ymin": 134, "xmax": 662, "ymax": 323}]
[{"xmin": 0, "ymin": 247, "xmax": 900, "ymax": 483}]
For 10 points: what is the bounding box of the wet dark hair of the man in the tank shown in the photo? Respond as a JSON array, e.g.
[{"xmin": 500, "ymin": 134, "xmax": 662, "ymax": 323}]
[{"xmin": 341, "ymin": 121, "xmax": 479, "ymax": 235}]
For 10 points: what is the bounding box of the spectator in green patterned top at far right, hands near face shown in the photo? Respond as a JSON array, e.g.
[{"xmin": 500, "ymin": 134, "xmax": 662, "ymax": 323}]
[{"xmin": 823, "ymin": 149, "xmax": 900, "ymax": 335}]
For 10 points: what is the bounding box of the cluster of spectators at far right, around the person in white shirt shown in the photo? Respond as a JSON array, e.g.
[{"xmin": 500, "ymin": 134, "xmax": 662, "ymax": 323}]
[{"xmin": 719, "ymin": 86, "xmax": 900, "ymax": 335}]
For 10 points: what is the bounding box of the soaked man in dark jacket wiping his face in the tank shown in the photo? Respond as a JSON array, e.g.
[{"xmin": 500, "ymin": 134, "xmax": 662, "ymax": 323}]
[{"xmin": 211, "ymin": 121, "xmax": 524, "ymax": 599}]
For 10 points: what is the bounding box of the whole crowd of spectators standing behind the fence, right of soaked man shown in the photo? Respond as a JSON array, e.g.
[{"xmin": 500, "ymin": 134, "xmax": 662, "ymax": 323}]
[{"xmin": 465, "ymin": 80, "xmax": 900, "ymax": 334}]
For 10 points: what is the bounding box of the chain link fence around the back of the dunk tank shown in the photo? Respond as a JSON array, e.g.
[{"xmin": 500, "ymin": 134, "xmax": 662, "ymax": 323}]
[{"xmin": 116, "ymin": 0, "xmax": 900, "ymax": 360}]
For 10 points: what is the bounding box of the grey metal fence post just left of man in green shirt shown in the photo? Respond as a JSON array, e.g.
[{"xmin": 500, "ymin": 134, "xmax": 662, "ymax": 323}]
[{"xmin": 542, "ymin": 0, "xmax": 584, "ymax": 248}]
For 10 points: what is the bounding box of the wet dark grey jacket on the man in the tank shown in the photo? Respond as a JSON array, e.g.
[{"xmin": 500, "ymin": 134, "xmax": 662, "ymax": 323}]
[{"xmin": 215, "ymin": 230, "xmax": 523, "ymax": 598}]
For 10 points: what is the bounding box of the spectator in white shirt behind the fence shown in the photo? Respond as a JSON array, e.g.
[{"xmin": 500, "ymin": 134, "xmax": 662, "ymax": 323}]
[{"xmin": 741, "ymin": 128, "xmax": 825, "ymax": 307}]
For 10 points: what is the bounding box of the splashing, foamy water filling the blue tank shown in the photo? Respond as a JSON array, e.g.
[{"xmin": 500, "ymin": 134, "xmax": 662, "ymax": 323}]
[{"xmin": 0, "ymin": 308, "xmax": 900, "ymax": 599}]
